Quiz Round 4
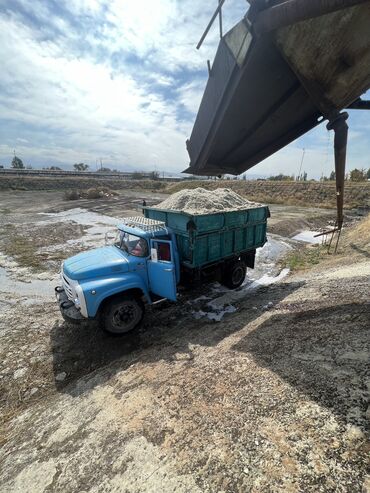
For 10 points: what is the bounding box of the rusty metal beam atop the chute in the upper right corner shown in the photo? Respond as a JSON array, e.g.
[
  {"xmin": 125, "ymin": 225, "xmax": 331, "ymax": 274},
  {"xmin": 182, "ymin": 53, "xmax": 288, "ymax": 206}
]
[{"xmin": 252, "ymin": 0, "xmax": 369, "ymax": 35}]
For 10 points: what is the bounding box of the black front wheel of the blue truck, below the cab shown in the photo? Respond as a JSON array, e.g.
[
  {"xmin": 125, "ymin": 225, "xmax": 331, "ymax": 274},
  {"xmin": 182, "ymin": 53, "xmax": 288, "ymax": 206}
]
[{"xmin": 101, "ymin": 295, "xmax": 144, "ymax": 335}]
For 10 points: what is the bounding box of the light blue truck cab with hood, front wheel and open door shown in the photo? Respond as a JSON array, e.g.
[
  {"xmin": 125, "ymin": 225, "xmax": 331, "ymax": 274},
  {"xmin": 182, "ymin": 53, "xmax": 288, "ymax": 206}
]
[{"xmin": 55, "ymin": 217, "xmax": 180, "ymax": 334}]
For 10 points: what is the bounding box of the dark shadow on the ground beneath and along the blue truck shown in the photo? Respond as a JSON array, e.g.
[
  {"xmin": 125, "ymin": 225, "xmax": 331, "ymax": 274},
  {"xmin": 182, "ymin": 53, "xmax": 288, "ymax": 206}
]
[{"xmin": 51, "ymin": 282, "xmax": 303, "ymax": 395}]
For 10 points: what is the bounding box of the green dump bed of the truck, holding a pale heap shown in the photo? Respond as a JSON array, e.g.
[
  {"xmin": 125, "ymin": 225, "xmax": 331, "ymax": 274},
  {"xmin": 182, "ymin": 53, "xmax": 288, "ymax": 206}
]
[{"xmin": 143, "ymin": 205, "xmax": 270, "ymax": 268}]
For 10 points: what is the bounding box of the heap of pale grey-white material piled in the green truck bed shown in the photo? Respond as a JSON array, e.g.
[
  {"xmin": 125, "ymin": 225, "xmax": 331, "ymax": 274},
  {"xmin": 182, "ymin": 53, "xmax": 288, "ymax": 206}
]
[{"xmin": 156, "ymin": 188, "xmax": 261, "ymax": 214}]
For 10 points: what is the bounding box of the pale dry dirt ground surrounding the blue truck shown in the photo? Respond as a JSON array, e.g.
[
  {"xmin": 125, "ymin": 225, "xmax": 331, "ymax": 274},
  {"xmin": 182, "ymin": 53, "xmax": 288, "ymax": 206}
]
[{"xmin": 0, "ymin": 191, "xmax": 370, "ymax": 493}]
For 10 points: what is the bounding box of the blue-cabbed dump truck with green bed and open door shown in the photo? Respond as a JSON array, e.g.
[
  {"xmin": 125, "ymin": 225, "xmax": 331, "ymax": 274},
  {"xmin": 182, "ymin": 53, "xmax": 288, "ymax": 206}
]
[{"xmin": 55, "ymin": 206, "xmax": 270, "ymax": 334}]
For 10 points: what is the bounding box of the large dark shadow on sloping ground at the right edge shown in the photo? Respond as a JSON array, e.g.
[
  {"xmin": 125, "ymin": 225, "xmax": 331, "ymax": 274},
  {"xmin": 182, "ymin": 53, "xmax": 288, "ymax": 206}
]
[{"xmin": 232, "ymin": 303, "xmax": 370, "ymax": 428}]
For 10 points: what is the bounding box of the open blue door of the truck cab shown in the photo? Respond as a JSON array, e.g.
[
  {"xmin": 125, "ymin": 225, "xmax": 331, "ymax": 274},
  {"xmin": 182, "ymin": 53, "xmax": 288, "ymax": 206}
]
[{"xmin": 147, "ymin": 240, "xmax": 177, "ymax": 301}]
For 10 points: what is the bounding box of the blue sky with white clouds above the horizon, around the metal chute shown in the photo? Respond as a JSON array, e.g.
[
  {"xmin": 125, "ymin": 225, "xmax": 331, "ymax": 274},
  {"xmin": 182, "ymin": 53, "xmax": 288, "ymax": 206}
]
[{"xmin": 0, "ymin": 0, "xmax": 370, "ymax": 178}]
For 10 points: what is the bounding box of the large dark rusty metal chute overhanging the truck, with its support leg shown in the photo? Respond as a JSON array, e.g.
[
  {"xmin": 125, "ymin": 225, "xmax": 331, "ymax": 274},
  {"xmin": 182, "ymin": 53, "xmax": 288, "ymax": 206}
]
[{"xmin": 185, "ymin": 0, "xmax": 370, "ymax": 252}]
